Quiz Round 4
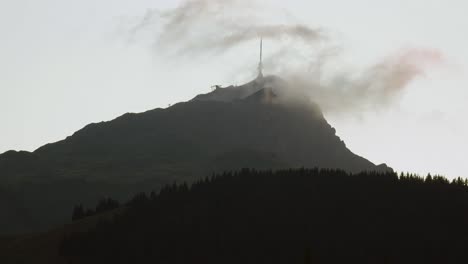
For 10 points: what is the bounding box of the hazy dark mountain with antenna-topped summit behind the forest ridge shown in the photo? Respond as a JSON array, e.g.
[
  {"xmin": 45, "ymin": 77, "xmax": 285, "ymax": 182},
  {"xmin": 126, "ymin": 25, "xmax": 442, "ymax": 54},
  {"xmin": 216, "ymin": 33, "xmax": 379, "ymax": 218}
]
[{"xmin": 0, "ymin": 76, "xmax": 391, "ymax": 232}]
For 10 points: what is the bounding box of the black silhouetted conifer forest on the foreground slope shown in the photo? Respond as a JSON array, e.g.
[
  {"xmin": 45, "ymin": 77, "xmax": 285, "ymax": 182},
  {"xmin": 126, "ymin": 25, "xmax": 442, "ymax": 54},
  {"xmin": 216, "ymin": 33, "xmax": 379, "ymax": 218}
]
[{"xmin": 59, "ymin": 169, "xmax": 468, "ymax": 264}]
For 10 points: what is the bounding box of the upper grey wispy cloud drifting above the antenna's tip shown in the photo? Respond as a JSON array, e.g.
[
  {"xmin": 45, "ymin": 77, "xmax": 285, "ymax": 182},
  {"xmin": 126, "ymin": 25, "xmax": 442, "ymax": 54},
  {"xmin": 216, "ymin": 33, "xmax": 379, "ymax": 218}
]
[{"xmin": 131, "ymin": 0, "xmax": 326, "ymax": 56}]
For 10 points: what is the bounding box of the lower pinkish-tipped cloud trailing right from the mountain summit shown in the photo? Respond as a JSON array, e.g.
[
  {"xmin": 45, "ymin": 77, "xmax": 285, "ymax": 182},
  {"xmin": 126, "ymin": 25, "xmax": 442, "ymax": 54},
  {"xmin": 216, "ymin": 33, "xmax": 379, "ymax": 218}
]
[{"xmin": 278, "ymin": 48, "xmax": 444, "ymax": 114}]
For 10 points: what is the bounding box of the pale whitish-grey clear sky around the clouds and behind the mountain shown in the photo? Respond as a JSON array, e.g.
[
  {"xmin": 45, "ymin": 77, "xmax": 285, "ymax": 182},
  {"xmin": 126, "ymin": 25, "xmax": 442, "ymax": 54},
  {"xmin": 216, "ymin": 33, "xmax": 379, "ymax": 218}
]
[{"xmin": 0, "ymin": 0, "xmax": 468, "ymax": 177}]
